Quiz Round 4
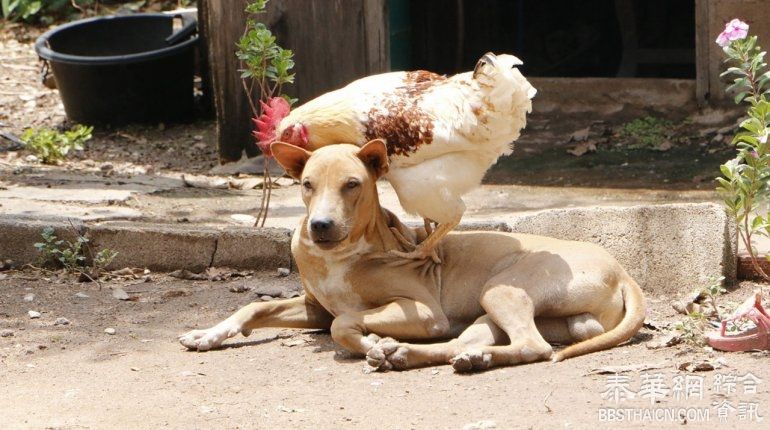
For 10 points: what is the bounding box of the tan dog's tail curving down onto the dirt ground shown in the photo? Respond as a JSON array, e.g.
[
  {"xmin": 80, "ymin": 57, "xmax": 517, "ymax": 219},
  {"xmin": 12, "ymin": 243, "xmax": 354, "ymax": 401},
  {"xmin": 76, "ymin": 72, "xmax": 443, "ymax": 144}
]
[{"xmin": 553, "ymin": 275, "xmax": 646, "ymax": 362}]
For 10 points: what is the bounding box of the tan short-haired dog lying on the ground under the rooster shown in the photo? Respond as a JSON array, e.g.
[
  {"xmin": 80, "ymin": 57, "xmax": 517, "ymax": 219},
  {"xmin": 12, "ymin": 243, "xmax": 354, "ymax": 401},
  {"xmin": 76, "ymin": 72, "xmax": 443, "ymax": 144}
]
[{"xmin": 179, "ymin": 140, "xmax": 645, "ymax": 371}]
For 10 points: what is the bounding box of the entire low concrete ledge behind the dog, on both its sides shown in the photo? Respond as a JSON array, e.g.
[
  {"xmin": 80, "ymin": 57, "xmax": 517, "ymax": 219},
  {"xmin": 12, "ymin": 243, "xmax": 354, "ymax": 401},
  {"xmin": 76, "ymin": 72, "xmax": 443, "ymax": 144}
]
[{"xmin": 0, "ymin": 203, "xmax": 737, "ymax": 293}]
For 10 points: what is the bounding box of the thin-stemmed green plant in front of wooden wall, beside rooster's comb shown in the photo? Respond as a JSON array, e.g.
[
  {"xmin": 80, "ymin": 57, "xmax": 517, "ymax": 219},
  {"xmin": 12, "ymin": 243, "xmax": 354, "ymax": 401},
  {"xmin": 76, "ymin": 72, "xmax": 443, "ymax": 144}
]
[{"xmin": 236, "ymin": 0, "xmax": 296, "ymax": 226}]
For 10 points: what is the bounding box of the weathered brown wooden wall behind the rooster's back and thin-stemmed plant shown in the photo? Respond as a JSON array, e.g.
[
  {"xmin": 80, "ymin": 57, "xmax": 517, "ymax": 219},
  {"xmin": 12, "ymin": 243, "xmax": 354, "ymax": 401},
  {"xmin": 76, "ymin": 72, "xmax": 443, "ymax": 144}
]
[{"xmin": 198, "ymin": 0, "xmax": 390, "ymax": 163}]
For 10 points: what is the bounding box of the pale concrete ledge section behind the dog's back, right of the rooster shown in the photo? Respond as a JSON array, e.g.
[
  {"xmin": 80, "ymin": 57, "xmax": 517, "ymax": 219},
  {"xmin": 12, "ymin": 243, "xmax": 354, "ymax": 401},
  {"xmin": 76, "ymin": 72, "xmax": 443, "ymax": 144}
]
[{"xmin": 500, "ymin": 203, "xmax": 738, "ymax": 293}]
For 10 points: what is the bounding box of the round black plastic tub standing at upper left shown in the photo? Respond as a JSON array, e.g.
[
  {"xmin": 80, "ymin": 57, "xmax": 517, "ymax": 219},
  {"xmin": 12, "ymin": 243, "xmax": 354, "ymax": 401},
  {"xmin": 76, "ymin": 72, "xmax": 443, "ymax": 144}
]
[{"xmin": 35, "ymin": 14, "xmax": 198, "ymax": 124}]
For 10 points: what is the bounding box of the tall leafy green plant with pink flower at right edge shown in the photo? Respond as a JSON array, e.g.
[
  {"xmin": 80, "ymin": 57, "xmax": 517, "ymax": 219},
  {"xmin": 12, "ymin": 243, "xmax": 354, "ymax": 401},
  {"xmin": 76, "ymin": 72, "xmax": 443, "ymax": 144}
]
[{"xmin": 717, "ymin": 20, "xmax": 770, "ymax": 280}]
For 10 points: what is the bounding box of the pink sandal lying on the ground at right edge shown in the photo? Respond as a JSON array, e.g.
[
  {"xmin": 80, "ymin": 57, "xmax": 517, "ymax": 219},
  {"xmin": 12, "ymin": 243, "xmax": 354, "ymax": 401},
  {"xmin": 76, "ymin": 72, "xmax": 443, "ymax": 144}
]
[{"xmin": 706, "ymin": 291, "xmax": 770, "ymax": 351}]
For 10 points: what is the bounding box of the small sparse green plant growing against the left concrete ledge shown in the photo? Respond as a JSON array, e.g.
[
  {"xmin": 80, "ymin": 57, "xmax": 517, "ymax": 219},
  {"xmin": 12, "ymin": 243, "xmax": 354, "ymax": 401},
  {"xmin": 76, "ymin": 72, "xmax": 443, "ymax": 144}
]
[{"xmin": 35, "ymin": 227, "xmax": 118, "ymax": 287}]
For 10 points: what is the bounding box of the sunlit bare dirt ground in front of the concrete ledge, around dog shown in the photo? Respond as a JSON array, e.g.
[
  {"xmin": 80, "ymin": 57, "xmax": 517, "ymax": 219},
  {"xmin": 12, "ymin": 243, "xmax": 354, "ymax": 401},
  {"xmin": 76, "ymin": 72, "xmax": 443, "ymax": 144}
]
[{"xmin": 0, "ymin": 270, "xmax": 770, "ymax": 429}]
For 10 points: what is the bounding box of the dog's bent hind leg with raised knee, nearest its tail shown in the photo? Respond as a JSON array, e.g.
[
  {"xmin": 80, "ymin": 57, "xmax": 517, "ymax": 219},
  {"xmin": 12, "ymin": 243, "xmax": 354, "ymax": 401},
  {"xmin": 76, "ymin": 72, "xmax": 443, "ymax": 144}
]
[{"xmin": 451, "ymin": 284, "xmax": 553, "ymax": 372}]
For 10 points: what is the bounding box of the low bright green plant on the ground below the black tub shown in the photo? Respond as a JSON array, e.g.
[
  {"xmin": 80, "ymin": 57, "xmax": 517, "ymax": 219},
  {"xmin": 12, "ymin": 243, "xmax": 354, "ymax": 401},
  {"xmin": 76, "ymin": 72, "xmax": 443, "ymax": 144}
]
[{"xmin": 21, "ymin": 125, "xmax": 94, "ymax": 164}]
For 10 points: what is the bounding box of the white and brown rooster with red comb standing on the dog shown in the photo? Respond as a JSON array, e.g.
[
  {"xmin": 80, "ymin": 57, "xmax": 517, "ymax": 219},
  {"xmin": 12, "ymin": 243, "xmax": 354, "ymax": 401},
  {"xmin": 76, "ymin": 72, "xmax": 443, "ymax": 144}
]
[{"xmin": 255, "ymin": 53, "xmax": 536, "ymax": 262}]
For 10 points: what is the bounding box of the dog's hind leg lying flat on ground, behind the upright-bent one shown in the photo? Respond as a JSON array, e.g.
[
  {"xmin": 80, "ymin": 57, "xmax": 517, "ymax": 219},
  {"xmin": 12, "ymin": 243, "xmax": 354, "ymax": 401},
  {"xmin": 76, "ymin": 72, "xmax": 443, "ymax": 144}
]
[{"xmin": 366, "ymin": 315, "xmax": 508, "ymax": 370}]
